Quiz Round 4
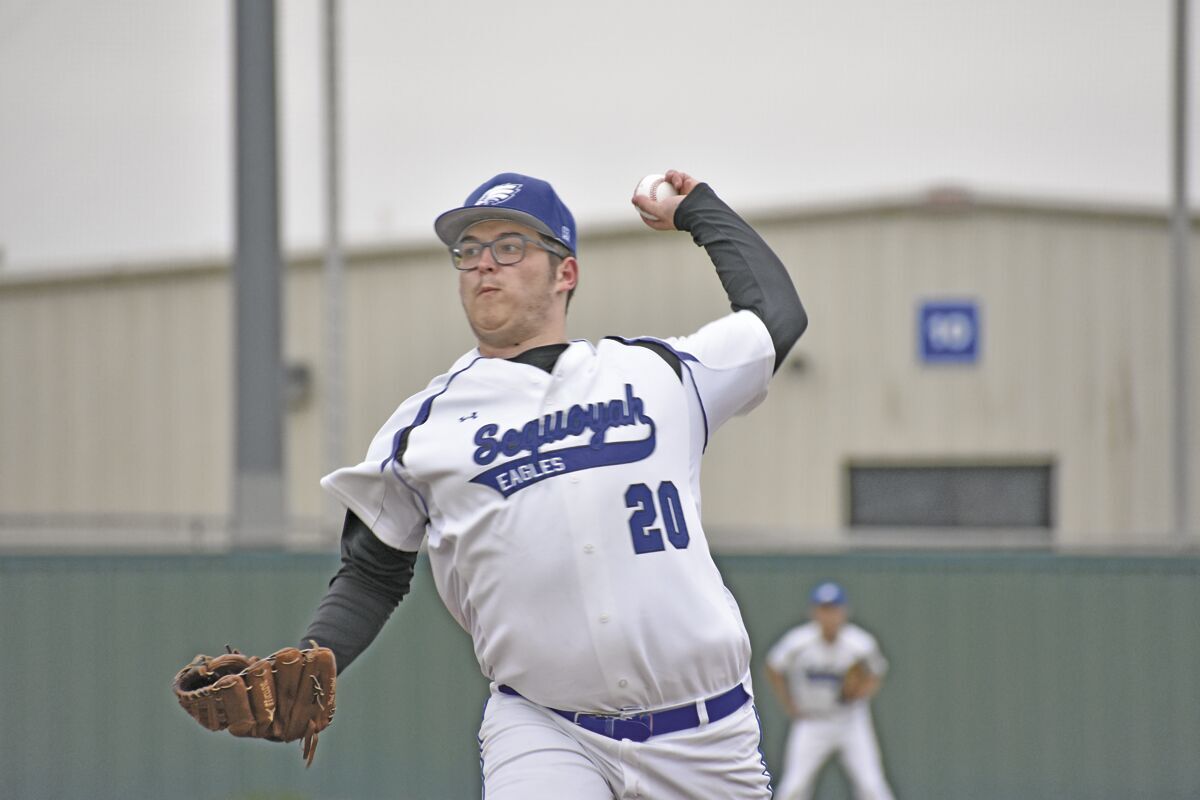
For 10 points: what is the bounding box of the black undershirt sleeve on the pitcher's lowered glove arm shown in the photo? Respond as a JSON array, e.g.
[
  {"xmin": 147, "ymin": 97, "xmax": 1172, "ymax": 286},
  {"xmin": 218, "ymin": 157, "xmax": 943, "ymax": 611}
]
[{"xmin": 300, "ymin": 511, "xmax": 416, "ymax": 674}]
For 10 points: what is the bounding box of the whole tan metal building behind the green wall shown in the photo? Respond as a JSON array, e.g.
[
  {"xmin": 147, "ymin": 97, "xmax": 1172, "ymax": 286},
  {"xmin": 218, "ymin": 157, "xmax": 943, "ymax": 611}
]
[{"xmin": 0, "ymin": 191, "xmax": 1200, "ymax": 551}]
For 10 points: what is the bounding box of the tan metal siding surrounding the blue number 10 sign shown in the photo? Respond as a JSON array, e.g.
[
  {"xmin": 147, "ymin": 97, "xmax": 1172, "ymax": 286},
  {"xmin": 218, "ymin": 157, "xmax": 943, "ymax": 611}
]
[{"xmin": 706, "ymin": 212, "xmax": 1170, "ymax": 543}]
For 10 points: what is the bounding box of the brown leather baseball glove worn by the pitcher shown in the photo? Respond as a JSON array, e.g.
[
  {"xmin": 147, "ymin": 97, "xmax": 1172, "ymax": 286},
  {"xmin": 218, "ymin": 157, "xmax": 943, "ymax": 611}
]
[{"xmin": 173, "ymin": 642, "xmax": 337, "ymax": 766}]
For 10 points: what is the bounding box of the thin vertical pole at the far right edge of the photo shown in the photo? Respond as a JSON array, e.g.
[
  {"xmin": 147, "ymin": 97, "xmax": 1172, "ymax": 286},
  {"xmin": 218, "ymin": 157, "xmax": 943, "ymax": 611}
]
[{"xmin": 1171, "ymin": 0, "xmax": 1192, "ymax": 539}]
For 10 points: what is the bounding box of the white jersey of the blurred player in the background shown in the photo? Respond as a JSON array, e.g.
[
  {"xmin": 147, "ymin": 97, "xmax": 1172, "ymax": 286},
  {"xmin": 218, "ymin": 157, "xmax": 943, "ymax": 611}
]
[{"xmin": 767, "ymin": 621, "xmax": 888, "ymax": 717}]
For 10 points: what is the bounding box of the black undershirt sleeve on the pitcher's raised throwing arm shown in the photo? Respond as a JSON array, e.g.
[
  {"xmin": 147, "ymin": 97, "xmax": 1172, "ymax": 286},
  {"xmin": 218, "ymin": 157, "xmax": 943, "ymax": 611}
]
[{"xmin": 674, "ymin": 184, "xmax": 809, "ymax": 369}]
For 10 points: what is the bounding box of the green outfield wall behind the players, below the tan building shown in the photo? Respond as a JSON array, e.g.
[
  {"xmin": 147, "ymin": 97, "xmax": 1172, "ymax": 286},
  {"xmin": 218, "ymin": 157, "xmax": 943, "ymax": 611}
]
[{"xmin": 0, "ymin": 553, "xmax": 1200, "ymax": 800}]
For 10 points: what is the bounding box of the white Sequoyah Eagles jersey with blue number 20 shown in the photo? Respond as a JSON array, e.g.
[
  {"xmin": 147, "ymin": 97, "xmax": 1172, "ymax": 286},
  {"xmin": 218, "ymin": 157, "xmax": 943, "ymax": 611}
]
[{"xmin": 322, "ymin": 311, "xmax": 775, "ymax": 714}]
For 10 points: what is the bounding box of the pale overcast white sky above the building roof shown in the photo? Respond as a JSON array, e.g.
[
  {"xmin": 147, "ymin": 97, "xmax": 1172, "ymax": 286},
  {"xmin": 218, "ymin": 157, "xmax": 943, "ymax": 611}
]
[{"xmin": 0, "ymin": 0, "xmax": 1200, "ymax": 271}]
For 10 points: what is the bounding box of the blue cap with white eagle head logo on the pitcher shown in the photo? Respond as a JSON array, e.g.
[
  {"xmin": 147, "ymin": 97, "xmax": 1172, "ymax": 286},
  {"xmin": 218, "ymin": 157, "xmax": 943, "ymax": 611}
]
[{"xmin": 433, "ymin": 173, "xmax": 575, "ymax": 255}]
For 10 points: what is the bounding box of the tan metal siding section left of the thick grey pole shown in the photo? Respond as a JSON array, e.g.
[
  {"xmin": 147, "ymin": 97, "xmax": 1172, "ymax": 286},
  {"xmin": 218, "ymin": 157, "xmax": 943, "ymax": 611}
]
[{"xmin": 0, "ymin": 272, "xmax": 229, "ymax": 517}]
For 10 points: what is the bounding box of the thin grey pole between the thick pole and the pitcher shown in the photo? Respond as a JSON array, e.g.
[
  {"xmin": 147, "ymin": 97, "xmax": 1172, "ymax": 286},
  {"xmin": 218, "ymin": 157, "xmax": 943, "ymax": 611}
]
[{"xmin": 323, "ymin": 0, "xmax": 346, "ymax": 535}]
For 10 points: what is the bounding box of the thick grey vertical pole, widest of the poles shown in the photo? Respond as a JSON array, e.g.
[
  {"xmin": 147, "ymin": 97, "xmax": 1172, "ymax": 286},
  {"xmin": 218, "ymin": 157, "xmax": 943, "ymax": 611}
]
[{"xmin": 233, "ymin": 0, "xmax": 286, "ymax": 549}]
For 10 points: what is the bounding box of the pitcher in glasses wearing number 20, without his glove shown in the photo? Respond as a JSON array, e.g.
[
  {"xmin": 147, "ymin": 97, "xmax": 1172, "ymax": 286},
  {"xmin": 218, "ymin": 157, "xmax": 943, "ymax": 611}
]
[{"xmin": 304, "ymin": 172, "xmax": 808, "ymax": 800}]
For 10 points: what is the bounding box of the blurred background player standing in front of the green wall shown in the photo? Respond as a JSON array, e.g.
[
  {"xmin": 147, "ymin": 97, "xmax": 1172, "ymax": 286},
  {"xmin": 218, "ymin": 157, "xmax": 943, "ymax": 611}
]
[{"xmin": 767, "ymin": 582, "xmax": 892, "ymax": 800}]
